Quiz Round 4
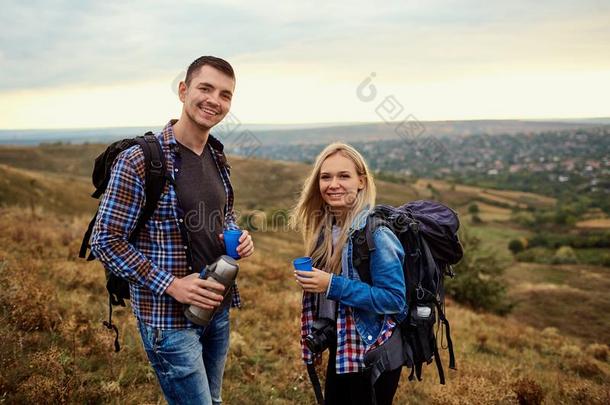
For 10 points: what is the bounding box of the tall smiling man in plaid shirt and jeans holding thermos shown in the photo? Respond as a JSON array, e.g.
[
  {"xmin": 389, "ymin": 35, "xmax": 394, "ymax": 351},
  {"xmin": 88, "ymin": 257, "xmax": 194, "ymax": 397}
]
[{"xmin": 91, "ymin": 56, "xmax": 254, "ymax": 404}]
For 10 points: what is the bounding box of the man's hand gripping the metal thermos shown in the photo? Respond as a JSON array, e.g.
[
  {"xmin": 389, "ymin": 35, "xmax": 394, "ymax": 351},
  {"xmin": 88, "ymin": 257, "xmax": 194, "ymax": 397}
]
[{"xmin": 165, "ymin": 273, "xmax": 225, "ymax": 309}]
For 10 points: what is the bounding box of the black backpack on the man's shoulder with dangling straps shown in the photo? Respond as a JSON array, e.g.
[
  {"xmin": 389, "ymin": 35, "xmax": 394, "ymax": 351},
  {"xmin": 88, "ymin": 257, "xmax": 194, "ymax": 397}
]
[{"xmin": 79, "ymin": 132, "xmax": 166, "ymax": 352}]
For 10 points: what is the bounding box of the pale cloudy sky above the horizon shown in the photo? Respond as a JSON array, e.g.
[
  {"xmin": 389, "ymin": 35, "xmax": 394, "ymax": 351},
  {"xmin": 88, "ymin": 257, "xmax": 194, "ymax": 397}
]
[{"xmin": 0, "ymin": 0, "xmax": 610, "ymax": 129}]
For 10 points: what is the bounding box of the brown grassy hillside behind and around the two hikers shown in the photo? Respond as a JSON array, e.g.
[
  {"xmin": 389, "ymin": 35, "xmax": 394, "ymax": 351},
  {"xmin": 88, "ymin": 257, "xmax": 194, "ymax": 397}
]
[{"xmin": 0, "ymin": 145, "xmax": 610, "ymax": 404}]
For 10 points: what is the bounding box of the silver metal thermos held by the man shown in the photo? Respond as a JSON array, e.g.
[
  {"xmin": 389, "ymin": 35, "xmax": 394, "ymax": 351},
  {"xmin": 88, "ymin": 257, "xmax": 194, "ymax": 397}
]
[{"xmin": 184, "ymin": 255, "xmax": 239, "ymax": 326}]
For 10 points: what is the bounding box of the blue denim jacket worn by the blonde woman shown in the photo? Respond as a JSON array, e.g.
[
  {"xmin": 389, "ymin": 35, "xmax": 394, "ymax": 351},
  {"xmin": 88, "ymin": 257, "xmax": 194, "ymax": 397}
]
[{"xmin": 326, "ymin": 208, "xmax": 407, "ymax": 344}]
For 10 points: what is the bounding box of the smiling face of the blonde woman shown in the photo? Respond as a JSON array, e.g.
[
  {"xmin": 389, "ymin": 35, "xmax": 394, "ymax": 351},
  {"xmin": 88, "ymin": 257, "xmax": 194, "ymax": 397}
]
[{"xmin": 319, "ymin": 152, "xmax": 364, "ymax": 210}]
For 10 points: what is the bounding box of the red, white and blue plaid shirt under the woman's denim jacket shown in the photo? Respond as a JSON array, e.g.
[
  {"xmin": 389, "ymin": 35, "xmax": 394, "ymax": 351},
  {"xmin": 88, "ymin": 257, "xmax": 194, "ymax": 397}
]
[{"xmin": 301, "ymin": 292, "xmax": 396, "ymax": 374}]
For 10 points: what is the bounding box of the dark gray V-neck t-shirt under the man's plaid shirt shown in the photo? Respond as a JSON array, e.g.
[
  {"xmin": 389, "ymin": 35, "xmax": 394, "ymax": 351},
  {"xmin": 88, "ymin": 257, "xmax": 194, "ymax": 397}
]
[{"xmin": 176, "ymin": 142, "xmax": 226, "ymax": 272}]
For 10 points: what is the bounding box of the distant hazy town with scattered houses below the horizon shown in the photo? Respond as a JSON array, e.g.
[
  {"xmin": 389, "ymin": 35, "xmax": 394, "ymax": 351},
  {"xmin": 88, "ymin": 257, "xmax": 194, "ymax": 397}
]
[{"xmin": 229, "ymin": 125, "xmax": 610, "ymax": 215}]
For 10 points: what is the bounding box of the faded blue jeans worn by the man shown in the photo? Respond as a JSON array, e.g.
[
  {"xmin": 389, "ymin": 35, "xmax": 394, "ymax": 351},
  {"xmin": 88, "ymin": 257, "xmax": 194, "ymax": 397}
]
[{"xmin": 138, "ymin": 305, "xmax": 229, "ymax": 405}]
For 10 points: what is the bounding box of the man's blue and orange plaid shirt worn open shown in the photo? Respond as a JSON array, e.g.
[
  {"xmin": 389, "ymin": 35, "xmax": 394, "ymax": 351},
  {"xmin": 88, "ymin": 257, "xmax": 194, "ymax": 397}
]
[{"xmin": 91, "ymin": 120, "xmax": 241, "ymax": 329}]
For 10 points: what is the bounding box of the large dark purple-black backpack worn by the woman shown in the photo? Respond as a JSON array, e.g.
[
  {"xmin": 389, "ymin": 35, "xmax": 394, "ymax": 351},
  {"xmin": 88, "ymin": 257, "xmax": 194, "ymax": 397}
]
[{"xmin": 352, "ymin": 200, "xmax": 463, "ymax": 384}]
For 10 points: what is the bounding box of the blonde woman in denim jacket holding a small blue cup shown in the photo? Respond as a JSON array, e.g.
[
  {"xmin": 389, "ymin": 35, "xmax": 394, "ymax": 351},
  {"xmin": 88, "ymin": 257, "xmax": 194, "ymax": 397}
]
[{"xmin": 292, "ymin": 143, "xmax": 406, "ymax": 405}]
